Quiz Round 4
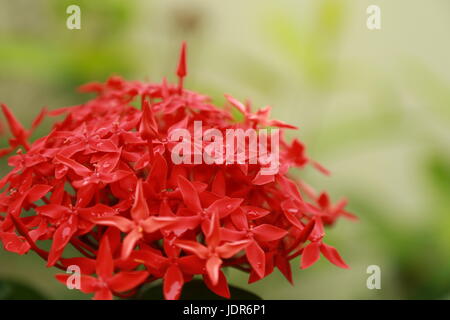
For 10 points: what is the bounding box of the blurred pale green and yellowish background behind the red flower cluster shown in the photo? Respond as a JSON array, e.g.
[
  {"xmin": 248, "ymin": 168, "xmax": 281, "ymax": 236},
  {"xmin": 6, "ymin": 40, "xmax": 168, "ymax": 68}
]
[{"xmin": 0, "ymin": 0, "xmax": 450, "ymax": 299}]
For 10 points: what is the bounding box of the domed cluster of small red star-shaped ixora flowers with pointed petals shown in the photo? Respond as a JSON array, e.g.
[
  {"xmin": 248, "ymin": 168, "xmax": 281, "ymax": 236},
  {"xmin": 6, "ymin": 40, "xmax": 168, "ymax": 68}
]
[{"xmin": 0, "ymin": 44, "xmax": 354, "ymax": 299}]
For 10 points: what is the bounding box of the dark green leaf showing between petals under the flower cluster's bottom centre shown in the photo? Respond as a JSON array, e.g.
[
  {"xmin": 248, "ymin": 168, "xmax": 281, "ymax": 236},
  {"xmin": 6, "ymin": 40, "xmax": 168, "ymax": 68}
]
[{"xmin": 137, "ymin": 280, "xmax": 262, "ymax": 300}]
